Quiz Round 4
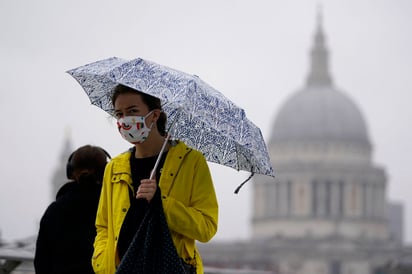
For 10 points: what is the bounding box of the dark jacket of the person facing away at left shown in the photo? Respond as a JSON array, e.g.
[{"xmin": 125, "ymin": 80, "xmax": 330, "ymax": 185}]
[{"xmin": 34, "ymin": 182, "xmax": 101, "ymax": 274}]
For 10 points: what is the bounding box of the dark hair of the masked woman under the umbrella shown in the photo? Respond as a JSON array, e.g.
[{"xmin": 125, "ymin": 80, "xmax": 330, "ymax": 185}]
[{"xmin": 112, "ymin": 85, "xmax": 167, "ymax": 136}]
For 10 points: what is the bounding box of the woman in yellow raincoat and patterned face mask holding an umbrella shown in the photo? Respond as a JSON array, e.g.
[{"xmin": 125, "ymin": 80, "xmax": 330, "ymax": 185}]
[{"xmin": 92, "ymin": 85, "xmax": 218, "ymax": 273}]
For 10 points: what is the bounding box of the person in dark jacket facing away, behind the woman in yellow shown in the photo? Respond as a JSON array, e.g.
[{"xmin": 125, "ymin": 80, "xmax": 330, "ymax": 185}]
[{"xmin": 34, "ymin": 145, "xmax": 110, "ymax": 274}]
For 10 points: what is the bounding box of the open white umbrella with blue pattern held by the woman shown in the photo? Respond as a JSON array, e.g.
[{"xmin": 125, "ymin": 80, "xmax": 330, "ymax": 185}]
[{"xmin": 68, "ymin": 57, "xmax": 274, "ymax": 192}]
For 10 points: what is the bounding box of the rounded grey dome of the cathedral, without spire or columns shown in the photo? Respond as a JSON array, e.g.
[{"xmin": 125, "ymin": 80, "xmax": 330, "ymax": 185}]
[{"xmin": 271, "ymin": 86, "xmax": 370, "ymax": 146}]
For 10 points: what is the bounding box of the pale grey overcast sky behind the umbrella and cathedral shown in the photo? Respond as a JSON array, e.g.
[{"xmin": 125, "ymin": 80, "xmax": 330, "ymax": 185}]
[{"xmin": 0, "ymin": 0, "xmax": 412, "ymax": 242}]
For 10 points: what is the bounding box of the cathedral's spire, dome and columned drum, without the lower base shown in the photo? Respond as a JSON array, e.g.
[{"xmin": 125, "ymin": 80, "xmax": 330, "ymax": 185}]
[{"xmin": 252, "ymin": 11, "xmax": 389, "ymax": 241}]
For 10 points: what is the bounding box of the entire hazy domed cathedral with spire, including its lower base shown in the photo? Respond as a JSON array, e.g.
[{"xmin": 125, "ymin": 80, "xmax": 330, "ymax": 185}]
[{"xmin": 200, "ymin": 9, "xmax": 412, "ymax": 274}]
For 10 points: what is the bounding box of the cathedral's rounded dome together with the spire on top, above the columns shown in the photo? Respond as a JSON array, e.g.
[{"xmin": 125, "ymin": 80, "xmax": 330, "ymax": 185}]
[{"xmin": 270, "ymin": 14, "xmax": 371, "ymax": 150}]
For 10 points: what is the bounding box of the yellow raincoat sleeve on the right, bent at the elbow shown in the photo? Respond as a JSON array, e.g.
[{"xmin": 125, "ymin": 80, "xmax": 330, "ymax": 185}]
[{"xmin": 162, "ymin": 150, "xmax": 218, "ymax": 242}]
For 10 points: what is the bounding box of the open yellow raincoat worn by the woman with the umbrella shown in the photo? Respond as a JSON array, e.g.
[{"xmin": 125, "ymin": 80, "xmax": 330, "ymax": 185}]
[{"xmin": 92, "ymin": 141, "xmax": 218, "ymax": 274}]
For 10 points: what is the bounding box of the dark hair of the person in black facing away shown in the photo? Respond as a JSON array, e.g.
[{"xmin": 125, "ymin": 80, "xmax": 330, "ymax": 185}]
[{"xmin": 67, "ymin": 145, "xmax": 111, "ymax": 183}]
